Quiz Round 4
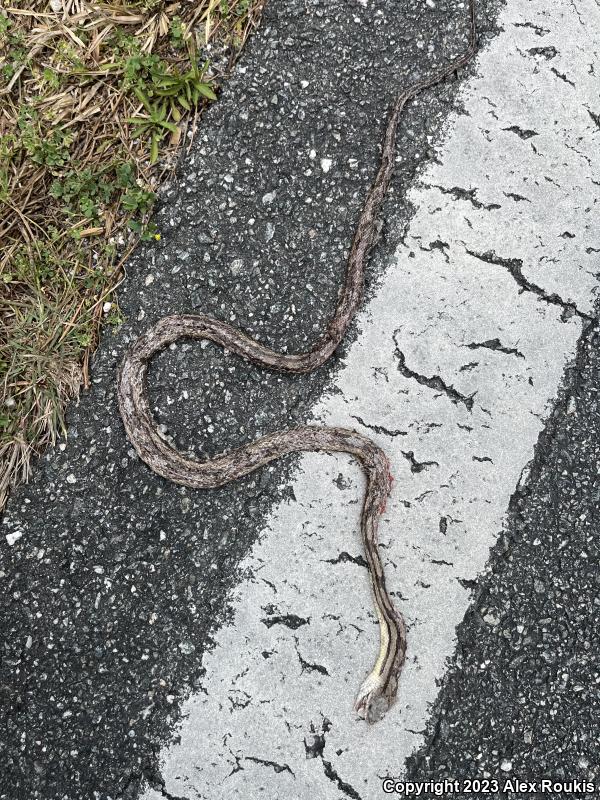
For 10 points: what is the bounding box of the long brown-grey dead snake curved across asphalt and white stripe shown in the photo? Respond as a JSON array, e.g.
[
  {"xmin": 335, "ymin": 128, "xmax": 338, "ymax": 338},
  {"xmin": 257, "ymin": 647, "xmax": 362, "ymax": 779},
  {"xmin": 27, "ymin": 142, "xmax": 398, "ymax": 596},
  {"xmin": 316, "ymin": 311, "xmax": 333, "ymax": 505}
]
[{"xmin": 117, "ymin": 0, "xmax": 477, "ymax": 723}]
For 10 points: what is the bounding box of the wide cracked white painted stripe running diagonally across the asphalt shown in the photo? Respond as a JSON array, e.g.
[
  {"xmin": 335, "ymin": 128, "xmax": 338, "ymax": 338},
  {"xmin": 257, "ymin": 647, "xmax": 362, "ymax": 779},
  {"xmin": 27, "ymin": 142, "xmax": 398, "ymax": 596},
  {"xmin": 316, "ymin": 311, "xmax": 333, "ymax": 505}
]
[{"xmin": 144, "ymin": 0, "xmax": 600, "ymax": 800}]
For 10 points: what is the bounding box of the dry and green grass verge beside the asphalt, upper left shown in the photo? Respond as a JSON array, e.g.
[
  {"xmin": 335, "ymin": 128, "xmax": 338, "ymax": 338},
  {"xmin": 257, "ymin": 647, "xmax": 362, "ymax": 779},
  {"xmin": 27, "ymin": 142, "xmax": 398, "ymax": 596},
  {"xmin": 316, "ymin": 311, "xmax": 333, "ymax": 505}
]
[{"xmin": 0, "ymin": 0, "xmax": 263, "ymax": 509}]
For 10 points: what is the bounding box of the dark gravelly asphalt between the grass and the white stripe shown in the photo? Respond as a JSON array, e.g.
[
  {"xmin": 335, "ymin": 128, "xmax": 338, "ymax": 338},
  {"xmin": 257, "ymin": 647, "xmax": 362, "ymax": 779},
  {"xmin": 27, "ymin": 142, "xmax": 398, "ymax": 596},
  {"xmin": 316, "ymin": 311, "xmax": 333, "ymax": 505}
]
[{"xmin": 0, "ymin": 0, "xmax": 502, "ymax": 800}]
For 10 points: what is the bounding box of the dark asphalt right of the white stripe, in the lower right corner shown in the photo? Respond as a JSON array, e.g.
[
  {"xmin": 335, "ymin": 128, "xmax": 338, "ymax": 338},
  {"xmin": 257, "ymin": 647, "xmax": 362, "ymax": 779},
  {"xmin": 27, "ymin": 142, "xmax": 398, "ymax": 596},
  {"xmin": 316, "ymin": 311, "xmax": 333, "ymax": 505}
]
[{"xmin": 405, "ymin": 316, "xmax": 600, "ymax": 800}]
